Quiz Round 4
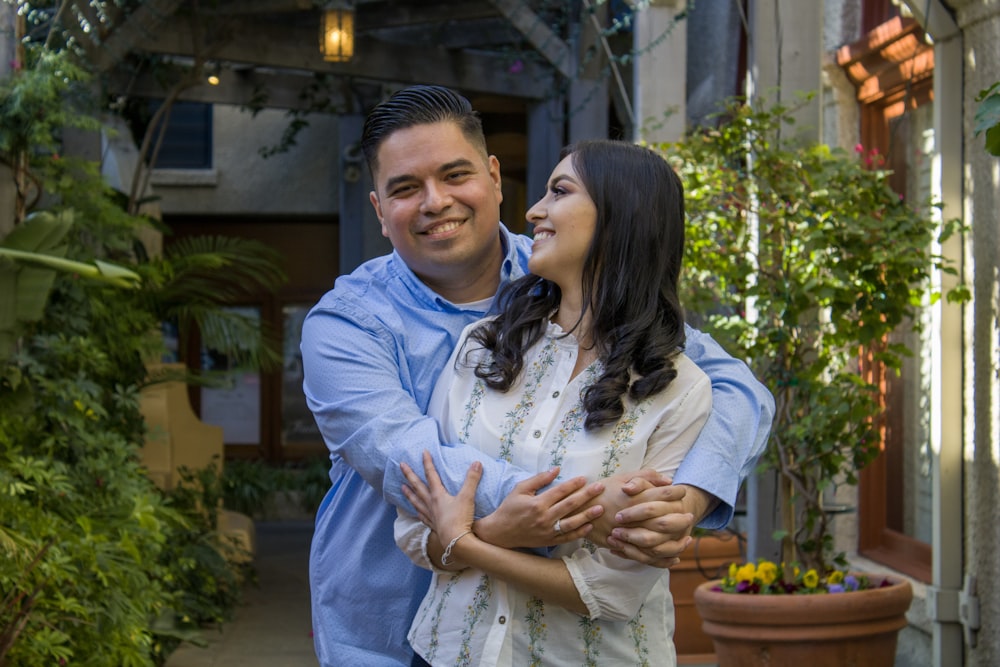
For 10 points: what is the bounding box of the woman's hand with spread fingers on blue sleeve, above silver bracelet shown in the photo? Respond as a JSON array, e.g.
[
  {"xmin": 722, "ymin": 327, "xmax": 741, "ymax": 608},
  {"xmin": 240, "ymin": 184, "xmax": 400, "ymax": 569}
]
[{"xmin": 400, "ymin": 451, "xmax": 483, "ymax": 544}]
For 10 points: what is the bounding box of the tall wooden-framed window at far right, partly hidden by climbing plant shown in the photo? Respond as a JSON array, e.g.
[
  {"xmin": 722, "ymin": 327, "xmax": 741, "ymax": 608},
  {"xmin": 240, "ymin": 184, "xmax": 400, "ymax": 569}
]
[{"xmin": 837, "ymin": 13, "xmax": 934, "ymax": 581}]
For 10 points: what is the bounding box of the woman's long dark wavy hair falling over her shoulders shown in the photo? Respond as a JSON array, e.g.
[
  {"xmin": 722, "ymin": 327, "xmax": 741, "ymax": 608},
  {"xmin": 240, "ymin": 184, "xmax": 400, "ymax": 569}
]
[{"xmin": 471, "ymin": 140, "xmax": 684, "ymax": 430}]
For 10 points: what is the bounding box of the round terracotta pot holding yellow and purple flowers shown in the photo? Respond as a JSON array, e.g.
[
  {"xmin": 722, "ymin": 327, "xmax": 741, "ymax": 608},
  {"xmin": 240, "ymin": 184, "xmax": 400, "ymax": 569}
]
[{"xmin": 694, "ymin": 578, "xmax": 913, "ymax": 667}]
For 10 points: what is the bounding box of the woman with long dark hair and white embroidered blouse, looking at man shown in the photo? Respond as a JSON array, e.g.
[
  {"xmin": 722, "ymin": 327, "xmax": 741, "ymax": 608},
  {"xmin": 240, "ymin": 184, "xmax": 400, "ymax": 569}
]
[{"xmin": 396, "ymin": 141, "xmax": 711, "ymax": 665}]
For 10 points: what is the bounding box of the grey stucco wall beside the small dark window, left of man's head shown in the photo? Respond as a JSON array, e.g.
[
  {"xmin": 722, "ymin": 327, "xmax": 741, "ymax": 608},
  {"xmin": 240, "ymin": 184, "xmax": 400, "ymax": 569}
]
[{"xmin": 153, "ymin": 105, "xmax": 340, "ymax": 215}]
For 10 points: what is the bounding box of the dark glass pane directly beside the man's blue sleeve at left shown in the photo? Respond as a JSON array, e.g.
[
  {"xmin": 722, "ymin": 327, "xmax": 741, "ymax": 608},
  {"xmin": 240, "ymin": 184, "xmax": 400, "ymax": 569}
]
[{"xmin": 281, "ymin": 303, "xmax": 323, "ymax": 446}]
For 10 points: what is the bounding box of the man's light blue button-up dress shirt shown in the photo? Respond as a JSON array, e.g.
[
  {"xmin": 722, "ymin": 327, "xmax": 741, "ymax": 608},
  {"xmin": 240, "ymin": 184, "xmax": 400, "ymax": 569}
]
[{"xmin": 301, "ymin": 226, "xmax": 774, "ymax": 667}]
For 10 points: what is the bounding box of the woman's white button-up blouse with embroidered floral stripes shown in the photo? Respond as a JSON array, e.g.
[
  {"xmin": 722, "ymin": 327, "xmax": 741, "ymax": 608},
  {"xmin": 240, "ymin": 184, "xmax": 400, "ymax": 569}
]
[{"xmin": 396, "ymin": 324, "xmax": 712, "ymax": 667}]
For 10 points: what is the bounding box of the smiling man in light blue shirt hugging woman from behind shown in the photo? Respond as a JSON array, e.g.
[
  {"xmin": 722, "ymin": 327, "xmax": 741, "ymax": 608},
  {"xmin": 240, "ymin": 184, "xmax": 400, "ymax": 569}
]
[{"xmin": 301, "ymin": 86, "xmax": 773, "ymax": 667}]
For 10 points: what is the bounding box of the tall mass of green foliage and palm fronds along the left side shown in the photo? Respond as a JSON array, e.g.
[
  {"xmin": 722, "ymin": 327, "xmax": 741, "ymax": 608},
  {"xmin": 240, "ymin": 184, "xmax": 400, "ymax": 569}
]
[{"xmin": 0, "ymin": 44, "xmax": 283, "ymax": 667}]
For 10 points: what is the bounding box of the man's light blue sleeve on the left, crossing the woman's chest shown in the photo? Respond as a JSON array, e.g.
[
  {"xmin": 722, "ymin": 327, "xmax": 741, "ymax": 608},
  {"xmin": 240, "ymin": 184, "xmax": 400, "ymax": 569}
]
[{"xmin": 301, "ymin": 301, "xmax": 529, "ymax": 516}]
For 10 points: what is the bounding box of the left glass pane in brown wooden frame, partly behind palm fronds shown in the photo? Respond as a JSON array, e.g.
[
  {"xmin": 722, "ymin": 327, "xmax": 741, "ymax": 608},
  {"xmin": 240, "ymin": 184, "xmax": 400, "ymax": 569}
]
[{"xmin": 201, "ymin": 307, "xmax": 260, "ymax": 445}]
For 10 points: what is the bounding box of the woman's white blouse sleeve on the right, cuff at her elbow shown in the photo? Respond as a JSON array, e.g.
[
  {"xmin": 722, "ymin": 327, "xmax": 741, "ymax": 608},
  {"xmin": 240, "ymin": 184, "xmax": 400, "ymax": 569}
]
[{"xmin": 563, "ymin": 373, "xmax": 712, "ymax": 621}]
